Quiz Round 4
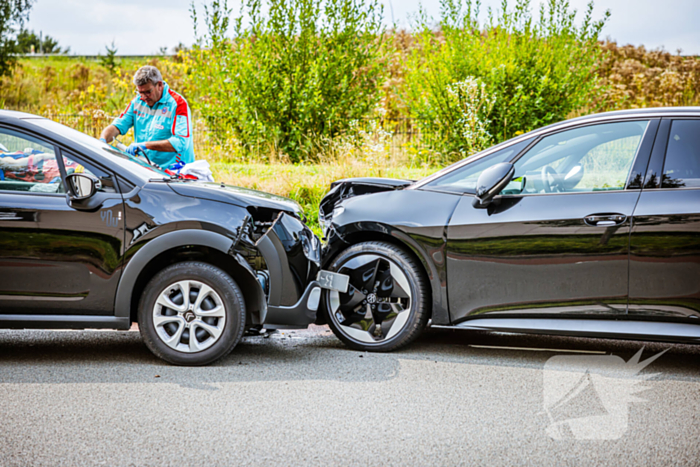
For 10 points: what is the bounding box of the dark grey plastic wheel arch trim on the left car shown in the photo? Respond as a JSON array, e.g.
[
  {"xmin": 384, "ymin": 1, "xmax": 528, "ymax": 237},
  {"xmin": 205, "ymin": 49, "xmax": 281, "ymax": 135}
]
[{"xmin": 114, "ymin": 229, "xmax": 266, "ymax": 319}]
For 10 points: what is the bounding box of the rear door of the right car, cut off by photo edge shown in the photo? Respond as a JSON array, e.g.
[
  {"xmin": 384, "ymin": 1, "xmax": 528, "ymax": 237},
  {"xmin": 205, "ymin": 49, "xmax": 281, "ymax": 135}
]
[{"xmin": 629, "ymin": 119, "xmax": 700, "ymax": 322}]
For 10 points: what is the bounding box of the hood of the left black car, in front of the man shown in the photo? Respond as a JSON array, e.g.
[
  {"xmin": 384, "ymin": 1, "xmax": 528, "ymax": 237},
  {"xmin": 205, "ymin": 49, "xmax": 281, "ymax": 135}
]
[{"xmin": 168, "ymin": 182, "xmax": 304, "ymax": 219}]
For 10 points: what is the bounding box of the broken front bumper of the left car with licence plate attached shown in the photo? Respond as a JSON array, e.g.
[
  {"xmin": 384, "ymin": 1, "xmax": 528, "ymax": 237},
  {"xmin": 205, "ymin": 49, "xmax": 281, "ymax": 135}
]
[{"xmin": 255, "ymin": 213, "xmax": 342, "ymax": 329}]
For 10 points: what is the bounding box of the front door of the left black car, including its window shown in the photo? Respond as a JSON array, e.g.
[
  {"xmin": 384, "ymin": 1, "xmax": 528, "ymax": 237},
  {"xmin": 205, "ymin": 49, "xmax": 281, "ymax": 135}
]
[{"xmin": 0, "ymin": 128, "xmax": 124, "ymax": 315}]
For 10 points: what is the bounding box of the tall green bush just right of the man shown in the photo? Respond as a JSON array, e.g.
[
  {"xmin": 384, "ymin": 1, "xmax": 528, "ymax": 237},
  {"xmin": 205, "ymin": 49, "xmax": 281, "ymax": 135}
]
[{"xmin": 189, "ymin": 0, "xmax": 385, "ymax": 162}]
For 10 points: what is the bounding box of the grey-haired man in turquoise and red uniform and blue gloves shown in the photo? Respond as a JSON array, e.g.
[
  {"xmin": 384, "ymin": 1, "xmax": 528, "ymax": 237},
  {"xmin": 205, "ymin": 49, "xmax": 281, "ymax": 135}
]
[{"xmin": 100, "ymin": 66, "xmax": 194, "ymax": 168}]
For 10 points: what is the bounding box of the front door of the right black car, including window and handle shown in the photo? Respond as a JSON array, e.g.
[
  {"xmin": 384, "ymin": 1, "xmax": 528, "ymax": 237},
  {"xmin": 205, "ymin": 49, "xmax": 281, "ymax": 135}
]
[{"xmin": 447, "ymin": 119, "xmax": 659, "ymax": 322}]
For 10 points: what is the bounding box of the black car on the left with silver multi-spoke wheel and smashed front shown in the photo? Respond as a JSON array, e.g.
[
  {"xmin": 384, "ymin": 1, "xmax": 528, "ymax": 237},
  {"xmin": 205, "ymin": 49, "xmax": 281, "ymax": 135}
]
[{"xmin": 0, "ymin": 111, "xmax": 347, "ymax": 365}]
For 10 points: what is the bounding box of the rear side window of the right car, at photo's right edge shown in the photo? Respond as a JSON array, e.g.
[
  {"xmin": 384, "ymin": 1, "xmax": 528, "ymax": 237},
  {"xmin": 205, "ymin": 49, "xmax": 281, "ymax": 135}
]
[{"xmin": 661, "ymin": 120, "xmax": 700, "ymax": 188}]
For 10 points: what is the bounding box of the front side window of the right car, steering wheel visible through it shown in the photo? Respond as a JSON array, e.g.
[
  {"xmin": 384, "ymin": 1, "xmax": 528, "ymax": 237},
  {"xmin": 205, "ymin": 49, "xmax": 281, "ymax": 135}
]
[{"xmin": 504, "ymin": 120, "xmax": 649, "ymax": 194}]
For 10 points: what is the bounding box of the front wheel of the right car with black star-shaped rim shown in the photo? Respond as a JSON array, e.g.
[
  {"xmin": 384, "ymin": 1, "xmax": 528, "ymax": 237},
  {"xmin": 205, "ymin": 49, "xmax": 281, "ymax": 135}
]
[{"xmin": 323, "ymin": 242, "xmax": 430, "ymax": 352}]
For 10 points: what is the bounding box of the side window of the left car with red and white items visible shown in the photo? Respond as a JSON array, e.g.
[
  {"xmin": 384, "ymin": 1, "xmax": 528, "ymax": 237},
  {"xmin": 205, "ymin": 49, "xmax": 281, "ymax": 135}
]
[{"xmin": 0, "ymin": 129, "xmax": 65, "ymax": 193}]
